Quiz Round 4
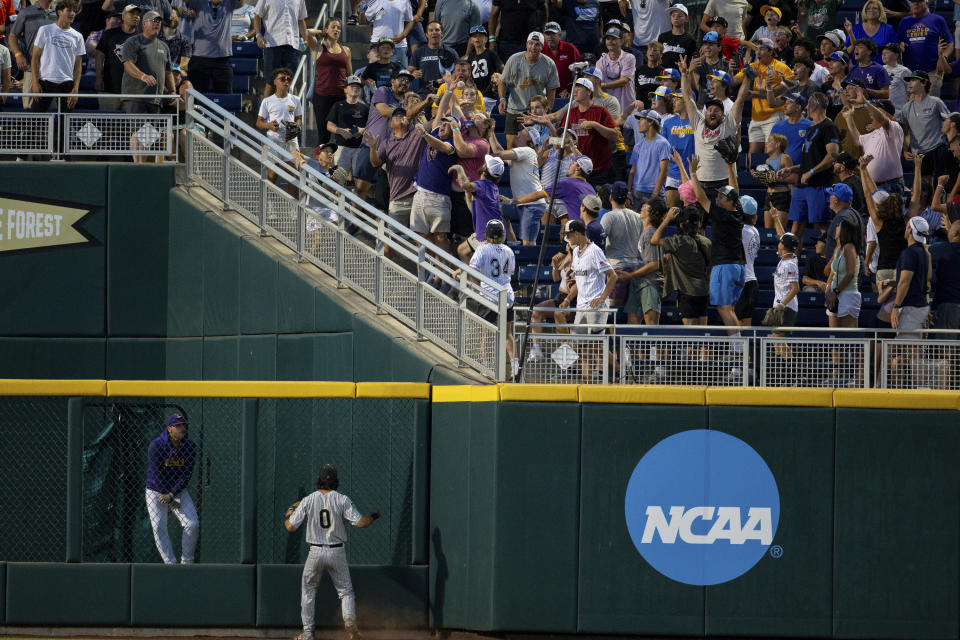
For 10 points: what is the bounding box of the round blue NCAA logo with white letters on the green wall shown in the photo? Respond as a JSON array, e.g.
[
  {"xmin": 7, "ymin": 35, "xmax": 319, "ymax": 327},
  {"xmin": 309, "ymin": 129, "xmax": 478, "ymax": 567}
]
[{"xmin": 624, "ymin": 429, "xmax": 780, "ymax": 585}]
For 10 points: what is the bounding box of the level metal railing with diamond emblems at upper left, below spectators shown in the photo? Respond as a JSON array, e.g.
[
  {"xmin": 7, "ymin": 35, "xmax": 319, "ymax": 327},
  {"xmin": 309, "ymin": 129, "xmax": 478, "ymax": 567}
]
[{"xmin": 0, "ymin": 93, "xmax": 180, "ymax": 163}]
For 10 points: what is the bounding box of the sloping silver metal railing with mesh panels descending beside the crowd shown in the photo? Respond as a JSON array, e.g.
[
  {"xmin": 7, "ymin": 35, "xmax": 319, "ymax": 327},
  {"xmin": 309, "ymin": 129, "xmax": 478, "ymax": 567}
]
[{"xmin": 186, "ymin": 90, "xmax": 507, "ymax": 381}]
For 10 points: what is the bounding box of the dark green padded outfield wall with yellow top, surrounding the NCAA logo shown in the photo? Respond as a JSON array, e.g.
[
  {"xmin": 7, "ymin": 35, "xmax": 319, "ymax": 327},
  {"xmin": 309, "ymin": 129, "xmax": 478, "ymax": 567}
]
[{"xmin": 430, "ymin": 385, "xmax": 960, "ymax": 638}]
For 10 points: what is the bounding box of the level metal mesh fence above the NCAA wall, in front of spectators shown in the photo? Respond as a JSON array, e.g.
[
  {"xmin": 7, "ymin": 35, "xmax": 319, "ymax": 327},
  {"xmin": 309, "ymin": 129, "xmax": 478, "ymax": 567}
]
[{"xmin": 515, "ymin": 322, "xmax": 960, "ymax": 390}]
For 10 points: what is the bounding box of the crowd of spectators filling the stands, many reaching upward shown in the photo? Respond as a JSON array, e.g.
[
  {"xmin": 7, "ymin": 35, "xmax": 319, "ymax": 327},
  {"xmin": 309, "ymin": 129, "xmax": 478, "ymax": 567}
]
[{"xmin": 0, "ymin": 0, "xmax": 960, "ymax": 378}]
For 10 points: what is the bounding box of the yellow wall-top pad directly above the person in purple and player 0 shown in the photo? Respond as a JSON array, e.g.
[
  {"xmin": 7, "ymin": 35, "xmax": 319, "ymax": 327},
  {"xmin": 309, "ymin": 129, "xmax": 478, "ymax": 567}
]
[{"xmin": 107, "ymin": 380, "xmax": 357, "ymax": 398}]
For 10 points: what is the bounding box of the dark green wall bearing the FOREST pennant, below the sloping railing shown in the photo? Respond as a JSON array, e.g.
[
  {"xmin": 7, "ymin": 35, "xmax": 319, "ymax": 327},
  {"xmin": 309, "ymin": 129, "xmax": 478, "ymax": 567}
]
[{"xmin": 0, "ymin": 163, "xmax": 466, "ymax": 384}]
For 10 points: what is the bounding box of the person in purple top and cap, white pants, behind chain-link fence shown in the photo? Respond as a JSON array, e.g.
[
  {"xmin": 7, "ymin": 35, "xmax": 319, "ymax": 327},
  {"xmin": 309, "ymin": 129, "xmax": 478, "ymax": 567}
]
[{"xmin": 146, "ymin": 413, "xmax": 200, "ymax": 564}]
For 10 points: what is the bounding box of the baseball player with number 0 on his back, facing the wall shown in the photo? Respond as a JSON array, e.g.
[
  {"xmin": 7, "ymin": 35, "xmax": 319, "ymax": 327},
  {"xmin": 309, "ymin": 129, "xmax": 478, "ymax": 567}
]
[{"xmin": 283, "ymin": 465, "xmax": 380, "ymax": 640}]
